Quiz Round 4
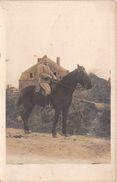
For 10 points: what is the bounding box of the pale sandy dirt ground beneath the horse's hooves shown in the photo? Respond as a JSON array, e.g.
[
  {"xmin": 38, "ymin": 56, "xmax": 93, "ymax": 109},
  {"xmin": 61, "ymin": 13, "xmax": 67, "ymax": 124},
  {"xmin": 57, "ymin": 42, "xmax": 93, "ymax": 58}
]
[{"xmin": 6, "ymin": 128, "xmax": 110, "ymax": 164}]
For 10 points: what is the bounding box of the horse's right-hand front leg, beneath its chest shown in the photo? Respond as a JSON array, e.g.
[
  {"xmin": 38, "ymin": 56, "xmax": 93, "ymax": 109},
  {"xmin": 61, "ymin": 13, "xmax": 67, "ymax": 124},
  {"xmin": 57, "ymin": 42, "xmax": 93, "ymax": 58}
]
[{"xmin": 62, "ymin": 107, "xmax": 68, "ymax": 136}]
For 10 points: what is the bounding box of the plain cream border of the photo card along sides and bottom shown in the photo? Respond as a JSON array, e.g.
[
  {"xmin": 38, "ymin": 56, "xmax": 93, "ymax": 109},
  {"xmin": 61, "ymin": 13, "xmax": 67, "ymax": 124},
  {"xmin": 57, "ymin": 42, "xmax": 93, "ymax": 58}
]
[{"xmin": 0, "ymin": 1, "xmax": 117, "ymax": 182}]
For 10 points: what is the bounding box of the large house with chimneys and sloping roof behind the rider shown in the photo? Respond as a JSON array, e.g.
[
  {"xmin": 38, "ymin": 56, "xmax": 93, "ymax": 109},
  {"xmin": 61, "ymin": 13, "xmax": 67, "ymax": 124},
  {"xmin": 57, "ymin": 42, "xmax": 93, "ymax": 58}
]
[{"xmin": 19, "ymin": 55, "xmax": 69, "ymax": 90}]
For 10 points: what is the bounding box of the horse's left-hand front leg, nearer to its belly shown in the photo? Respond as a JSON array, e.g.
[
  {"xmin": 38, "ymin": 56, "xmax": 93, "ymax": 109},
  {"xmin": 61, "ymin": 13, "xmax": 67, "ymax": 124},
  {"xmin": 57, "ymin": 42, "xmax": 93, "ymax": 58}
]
[{"xmin": 52, "ymin": 109, "xmax": 60, "ymax": 137}]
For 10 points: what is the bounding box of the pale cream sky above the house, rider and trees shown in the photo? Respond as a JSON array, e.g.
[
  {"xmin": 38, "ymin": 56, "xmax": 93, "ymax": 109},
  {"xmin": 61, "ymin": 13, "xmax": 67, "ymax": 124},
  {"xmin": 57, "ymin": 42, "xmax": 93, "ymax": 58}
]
[{"xmin": 2, "ymin": 1, "xmax": 115, "ymax": 87}]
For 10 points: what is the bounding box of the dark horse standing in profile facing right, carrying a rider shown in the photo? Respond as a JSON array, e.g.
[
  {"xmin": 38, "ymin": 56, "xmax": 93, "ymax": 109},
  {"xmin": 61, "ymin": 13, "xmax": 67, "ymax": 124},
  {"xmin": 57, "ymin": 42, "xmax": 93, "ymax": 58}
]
[{"xmin": 17, "ymin": 65, "xmax": 92, "ymax": 137}]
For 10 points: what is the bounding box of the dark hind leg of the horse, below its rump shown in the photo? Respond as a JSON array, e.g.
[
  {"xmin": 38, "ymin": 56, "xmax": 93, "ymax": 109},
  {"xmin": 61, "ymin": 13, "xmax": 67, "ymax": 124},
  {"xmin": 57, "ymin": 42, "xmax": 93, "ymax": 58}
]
[{"xmin": 21, "ymin": 105, "xmax": 33, "ymax": 133}]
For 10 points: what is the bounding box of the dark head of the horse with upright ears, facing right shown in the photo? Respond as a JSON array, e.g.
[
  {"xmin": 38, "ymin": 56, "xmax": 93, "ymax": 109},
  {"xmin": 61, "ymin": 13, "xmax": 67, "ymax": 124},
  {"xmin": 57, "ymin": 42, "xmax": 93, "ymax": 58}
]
[{"xmin": 77, "ymin": 65, "xmax": 92, "ymax": 89}]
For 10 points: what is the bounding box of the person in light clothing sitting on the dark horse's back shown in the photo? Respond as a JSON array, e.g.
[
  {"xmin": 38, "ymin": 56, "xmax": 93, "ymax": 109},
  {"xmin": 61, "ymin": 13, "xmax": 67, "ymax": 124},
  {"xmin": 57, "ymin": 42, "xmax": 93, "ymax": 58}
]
[{"xmin": 38, "ymin": 56, "xmax": 57, "ymax": 96}]
